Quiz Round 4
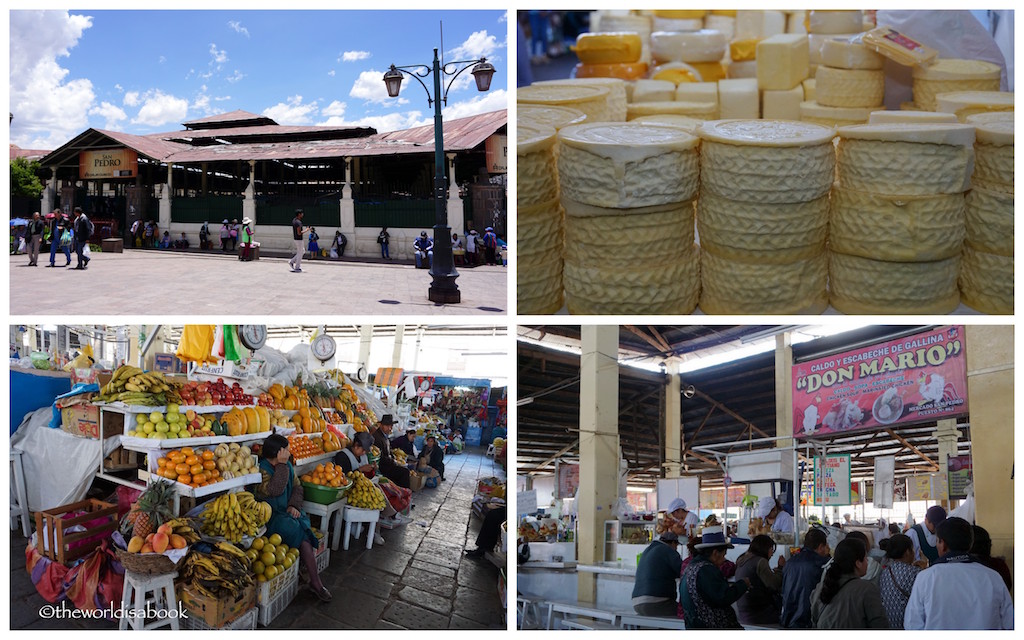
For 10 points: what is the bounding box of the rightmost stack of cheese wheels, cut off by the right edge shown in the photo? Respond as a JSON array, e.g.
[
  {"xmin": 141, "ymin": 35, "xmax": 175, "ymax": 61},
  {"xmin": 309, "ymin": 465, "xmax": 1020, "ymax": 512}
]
[{"xmin": 959, "ymin": 113, "xmax": 1014, "ymax": 313}]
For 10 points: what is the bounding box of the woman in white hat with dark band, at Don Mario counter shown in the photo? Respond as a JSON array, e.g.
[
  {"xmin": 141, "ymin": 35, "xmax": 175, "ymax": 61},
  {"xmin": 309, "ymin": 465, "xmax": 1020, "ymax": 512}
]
[{"xmin": 679, "ymin": 526, "xmax": 751, "ymax": 629}]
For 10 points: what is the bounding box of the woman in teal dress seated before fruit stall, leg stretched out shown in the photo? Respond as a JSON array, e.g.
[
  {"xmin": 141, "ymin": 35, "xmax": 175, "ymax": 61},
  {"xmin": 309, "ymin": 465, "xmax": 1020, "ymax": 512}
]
[{"xmin": 255, "ymin": 434, "xmax": 332, "ymax": 602}]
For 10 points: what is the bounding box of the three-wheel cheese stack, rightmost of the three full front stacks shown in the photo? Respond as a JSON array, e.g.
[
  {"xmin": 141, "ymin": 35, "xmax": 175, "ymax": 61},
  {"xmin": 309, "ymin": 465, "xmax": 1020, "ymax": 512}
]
[{"xmin": 828, "ymin": 123, "xmax": 974, "ymax": 313}]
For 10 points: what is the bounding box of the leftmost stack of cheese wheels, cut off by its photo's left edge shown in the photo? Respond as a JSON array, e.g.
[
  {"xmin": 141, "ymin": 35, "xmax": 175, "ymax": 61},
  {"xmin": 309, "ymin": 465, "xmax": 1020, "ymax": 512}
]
[{"xmin": 516, "ymin": 119, "xmax": 564, "ymax": 314}]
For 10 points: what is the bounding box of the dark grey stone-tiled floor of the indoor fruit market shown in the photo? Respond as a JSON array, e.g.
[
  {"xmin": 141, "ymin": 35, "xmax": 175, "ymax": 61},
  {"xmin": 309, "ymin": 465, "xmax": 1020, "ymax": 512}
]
[{"xmin": 10, "ymin": 449, "xmax": 507, "ymax": 630}]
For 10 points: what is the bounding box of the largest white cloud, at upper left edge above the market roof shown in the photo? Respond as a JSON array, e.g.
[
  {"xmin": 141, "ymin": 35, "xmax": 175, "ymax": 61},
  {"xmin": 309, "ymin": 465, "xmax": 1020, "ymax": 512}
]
[{"xmin": 9, "ymin": 10, "xmax": 95, "ymax": 148}]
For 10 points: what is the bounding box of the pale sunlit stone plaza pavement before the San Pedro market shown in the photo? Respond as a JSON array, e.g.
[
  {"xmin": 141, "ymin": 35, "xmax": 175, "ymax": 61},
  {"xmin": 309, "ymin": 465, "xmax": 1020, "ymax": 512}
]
[{"xmin": 9, "ymin": 250, "xmax": 512, "ymax": 315}]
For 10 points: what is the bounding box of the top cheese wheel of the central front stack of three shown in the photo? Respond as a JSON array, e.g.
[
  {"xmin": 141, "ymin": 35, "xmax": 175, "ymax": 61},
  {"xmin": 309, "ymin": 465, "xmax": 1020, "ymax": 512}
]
[{"xmin": 697, "ymin": 120, "xmax": 836, "ymax": 203}]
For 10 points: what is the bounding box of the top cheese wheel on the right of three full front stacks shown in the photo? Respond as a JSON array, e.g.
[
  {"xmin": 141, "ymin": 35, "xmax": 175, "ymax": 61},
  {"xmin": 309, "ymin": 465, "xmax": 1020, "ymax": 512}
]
[{"xmin": 837, "ymin": 124, "xmax": 974, "ymax": 196}]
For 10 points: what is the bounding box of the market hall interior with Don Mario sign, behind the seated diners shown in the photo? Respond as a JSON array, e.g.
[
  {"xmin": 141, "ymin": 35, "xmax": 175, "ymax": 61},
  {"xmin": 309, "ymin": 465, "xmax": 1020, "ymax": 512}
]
[{"xmin": 516, "ymin": 325, "xmax": 1014, "ymax": 629}]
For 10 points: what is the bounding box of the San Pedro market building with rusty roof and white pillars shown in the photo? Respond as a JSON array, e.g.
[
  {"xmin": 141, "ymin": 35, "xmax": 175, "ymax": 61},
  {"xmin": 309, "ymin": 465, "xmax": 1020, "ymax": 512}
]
[{"xmin": 30, "ymin": 110, "xmax": 508, "ymax": 258}]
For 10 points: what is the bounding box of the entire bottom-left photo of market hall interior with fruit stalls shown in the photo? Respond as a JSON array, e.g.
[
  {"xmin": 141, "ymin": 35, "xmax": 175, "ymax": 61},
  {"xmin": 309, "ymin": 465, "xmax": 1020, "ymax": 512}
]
[{"xmin": 10, "ymin": 325, "xmax": 508, "ymax": 631}]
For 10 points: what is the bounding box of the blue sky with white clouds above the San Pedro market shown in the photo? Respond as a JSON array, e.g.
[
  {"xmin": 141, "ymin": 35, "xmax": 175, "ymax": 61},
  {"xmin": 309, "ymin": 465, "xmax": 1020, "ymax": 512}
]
[{"xmin": 10, "ymin": 10, "xmax": 510, "ymax": 148}]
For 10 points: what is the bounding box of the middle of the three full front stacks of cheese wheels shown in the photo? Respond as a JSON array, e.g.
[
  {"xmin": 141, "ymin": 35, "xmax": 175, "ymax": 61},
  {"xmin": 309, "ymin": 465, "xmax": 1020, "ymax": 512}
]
[{"xmin": 697, "ymin": 120, "xmax": 836, "ymax": 314}]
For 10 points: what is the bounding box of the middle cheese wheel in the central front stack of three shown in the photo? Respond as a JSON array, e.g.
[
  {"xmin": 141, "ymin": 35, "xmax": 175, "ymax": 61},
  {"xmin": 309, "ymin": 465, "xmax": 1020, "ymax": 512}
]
[{"xmin": 697, "ymin": 189, "xmax": 828, "ymax": 264}]
